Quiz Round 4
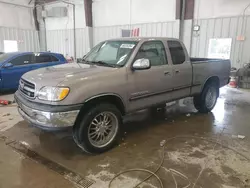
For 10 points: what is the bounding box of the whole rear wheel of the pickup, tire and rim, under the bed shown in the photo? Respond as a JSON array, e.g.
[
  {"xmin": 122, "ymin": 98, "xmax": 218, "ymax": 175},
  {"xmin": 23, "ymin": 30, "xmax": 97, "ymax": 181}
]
[{"xmin": 193, "ymin": 83, "xmax": 219, "ymax": 113}]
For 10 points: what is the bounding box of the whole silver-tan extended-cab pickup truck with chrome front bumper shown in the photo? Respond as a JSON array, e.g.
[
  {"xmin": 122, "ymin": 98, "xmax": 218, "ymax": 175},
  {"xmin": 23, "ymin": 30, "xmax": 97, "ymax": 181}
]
[{"xmin": 15, "ymin": 38, "xmax": 230, "ymax": 153}]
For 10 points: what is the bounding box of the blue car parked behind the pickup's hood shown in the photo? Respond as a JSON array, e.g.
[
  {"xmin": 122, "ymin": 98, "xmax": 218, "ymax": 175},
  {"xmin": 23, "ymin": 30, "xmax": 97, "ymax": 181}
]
[{"xmin": 0, "ymin": 52, "xmax": 67, "ymax": 91}]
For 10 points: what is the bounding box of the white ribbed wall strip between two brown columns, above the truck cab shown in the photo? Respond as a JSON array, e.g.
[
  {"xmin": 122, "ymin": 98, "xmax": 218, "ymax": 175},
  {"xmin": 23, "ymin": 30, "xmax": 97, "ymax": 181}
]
[{"xmin": 93, "ymin": 21, "xmax": 179, "ymax": 44}]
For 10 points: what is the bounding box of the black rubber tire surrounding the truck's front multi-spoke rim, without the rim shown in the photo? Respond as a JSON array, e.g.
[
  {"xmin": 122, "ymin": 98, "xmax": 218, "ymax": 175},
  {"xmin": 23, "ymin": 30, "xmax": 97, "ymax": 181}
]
[{"xmin": 73, "ymin": 103, "xmax": 122, "ymax": 154}]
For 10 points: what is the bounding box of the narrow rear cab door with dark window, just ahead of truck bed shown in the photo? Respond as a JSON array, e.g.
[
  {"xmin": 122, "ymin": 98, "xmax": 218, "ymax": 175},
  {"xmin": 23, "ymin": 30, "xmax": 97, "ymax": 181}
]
[{"xmin": 168, "ymin": 40, "xmax": 193, "ymax": 99}]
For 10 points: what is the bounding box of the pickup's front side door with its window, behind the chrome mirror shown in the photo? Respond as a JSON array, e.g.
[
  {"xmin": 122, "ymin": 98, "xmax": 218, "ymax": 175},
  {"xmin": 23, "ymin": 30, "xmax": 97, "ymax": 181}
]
[{"xmin": 128, "ymin": 41, "xmax": 173, "ymax": 111}]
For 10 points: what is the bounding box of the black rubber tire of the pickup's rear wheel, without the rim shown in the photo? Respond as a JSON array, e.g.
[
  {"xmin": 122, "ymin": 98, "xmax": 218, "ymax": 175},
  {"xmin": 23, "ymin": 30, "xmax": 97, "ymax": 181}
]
[{"xmin": 193, "ymin": 83, "xmax": 219, "ymax": 113}]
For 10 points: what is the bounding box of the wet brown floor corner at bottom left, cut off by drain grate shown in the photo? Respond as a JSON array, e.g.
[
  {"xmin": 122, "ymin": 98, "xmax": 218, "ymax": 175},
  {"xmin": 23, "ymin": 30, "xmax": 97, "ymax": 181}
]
[{"xmin": 0, "ymin": 137, "xmax": 74, "ymax": 188}]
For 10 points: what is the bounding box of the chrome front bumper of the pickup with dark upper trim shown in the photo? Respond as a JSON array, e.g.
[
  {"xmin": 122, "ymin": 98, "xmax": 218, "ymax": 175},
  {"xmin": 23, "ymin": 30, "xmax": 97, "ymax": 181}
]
[{"xmin": 15, "ymin": 91, "xmax": 82, "ymax": 130}]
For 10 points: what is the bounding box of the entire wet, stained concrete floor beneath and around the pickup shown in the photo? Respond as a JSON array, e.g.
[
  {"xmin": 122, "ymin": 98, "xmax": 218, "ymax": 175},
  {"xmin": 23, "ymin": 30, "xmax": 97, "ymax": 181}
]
[{"xmin": 0, "ymin": 87, "xmax": 250, "ymax": 188}]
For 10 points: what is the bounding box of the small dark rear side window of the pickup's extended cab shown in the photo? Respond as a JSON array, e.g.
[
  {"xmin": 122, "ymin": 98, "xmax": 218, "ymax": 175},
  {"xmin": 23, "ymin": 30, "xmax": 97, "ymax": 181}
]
[{"xmin": 168, "ymin": 40, "xmax": 186, "ymax": 65}]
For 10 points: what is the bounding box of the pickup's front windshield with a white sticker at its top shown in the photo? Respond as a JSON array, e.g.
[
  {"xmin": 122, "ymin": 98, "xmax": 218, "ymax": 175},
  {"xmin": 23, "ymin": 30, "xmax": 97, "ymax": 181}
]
[{"xmin": 83, "ymin": 41, "xmax": 137, "ymax": 67}]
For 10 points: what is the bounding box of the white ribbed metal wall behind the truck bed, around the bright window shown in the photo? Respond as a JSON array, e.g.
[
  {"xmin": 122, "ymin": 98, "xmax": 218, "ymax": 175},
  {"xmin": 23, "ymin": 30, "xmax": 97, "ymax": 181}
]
[{"xmin": 191, "ymin": 16, "xmax": 250, "ymax": 68}]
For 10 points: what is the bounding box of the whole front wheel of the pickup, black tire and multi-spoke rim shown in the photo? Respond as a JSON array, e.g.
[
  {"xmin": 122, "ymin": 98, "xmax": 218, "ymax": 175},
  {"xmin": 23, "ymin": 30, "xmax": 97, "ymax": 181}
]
[{"xmin": 74, "ymin": 104, "xmax": 122, "ymax": 154}]
